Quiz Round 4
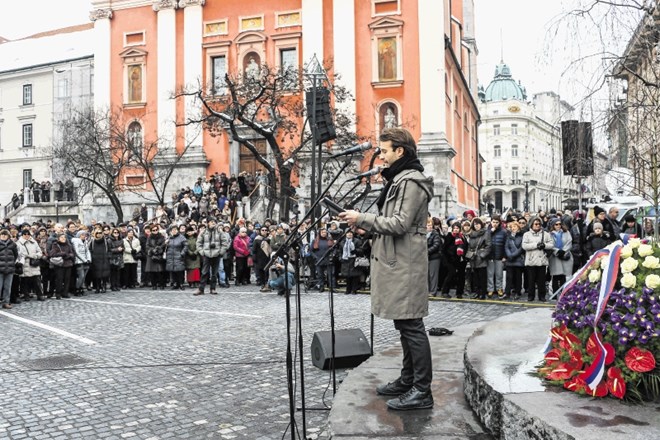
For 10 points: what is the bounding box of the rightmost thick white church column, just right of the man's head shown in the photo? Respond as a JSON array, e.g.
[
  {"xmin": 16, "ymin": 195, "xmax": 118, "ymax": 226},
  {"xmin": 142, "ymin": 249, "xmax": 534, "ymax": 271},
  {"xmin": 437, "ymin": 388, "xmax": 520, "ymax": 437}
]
[{"xmin": 417, "ymin": 0, "xmax": 456, "ymax": 212}]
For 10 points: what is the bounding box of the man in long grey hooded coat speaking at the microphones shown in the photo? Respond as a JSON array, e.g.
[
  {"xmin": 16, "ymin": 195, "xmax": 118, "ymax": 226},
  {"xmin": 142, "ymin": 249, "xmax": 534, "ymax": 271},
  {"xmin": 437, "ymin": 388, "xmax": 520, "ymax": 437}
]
[{"xmin": 339, "ymin": 128, "xmax": 433, "ymax": 410}]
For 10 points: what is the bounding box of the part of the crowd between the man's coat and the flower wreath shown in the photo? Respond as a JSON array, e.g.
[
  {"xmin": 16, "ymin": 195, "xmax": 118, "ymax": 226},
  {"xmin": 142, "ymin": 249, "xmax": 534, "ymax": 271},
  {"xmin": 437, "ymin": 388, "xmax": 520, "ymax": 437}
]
[{"xmin": 427, "ymin": 206, "xmax": 654, "ymax": 302}]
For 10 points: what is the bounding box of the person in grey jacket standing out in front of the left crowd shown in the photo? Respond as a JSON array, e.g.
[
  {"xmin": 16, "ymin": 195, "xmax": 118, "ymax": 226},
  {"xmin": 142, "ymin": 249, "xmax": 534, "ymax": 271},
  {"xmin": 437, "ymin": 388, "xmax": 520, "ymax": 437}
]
[{"xmin": 193, "ymin": 217, "xmax": 231, "ymax": 296}]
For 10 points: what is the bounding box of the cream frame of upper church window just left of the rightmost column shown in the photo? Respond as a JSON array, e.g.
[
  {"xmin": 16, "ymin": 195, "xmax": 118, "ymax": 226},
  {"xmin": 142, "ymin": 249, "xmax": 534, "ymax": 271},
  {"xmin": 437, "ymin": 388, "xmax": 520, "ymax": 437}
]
[{"xmin": 369, "ymin": 17, "xmax": 403, "ymax": 88}]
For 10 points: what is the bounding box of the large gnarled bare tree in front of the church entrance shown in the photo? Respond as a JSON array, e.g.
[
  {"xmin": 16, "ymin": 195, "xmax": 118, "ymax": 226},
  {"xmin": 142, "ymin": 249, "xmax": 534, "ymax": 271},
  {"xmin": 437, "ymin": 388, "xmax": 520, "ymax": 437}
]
[{"xmin": 176, "ymin": 65, "xmax": 356, "ymax": 220}]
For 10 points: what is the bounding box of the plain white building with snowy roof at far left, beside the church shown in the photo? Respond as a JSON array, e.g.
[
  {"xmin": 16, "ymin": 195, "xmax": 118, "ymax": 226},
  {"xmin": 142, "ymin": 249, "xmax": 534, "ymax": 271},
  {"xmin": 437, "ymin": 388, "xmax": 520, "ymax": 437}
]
[{"xmin": 0, "ymin": 24, "xmax": 94, "ymax": 217}]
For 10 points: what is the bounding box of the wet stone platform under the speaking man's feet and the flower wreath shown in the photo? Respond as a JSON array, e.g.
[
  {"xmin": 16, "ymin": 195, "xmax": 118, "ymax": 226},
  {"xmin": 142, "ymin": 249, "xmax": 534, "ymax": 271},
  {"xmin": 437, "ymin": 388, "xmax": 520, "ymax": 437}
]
[{"xmin": 329, "ymin": 309, "xmax": 660, "ymax": 440}]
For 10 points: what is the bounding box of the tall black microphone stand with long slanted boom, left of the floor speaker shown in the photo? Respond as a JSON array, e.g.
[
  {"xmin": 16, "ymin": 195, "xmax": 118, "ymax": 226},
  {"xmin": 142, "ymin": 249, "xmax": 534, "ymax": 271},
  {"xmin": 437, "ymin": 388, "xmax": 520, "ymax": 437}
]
[{"xmin": 264, "ymin": 156, "xmax": 350, "ymax": 440}]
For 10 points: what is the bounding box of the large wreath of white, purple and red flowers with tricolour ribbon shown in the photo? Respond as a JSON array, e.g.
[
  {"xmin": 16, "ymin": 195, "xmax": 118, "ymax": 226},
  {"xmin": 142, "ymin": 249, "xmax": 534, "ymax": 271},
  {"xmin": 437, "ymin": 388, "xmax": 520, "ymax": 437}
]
[{"xmin": 537, "ymin": 238, "xmax": 660, "ymax": 402}]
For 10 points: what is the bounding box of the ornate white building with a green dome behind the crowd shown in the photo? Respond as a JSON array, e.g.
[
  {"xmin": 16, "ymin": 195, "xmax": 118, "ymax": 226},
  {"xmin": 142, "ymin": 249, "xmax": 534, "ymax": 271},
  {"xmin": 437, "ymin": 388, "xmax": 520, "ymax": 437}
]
[{"xmin": 479, "ymin": 61, "xmax": 576, "ymax": 212}]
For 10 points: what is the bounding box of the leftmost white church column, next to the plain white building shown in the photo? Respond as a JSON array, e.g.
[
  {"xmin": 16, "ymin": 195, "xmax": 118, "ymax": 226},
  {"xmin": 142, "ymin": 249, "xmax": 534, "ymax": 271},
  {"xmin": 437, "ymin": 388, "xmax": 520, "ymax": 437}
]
[{"xmin": 89, "ymin": 8, "xmax": 112, "ymax": 109}]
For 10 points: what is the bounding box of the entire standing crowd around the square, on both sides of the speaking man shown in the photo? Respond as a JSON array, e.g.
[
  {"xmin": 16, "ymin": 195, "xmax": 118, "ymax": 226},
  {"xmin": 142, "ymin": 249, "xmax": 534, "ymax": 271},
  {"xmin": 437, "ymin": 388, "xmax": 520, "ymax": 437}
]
[{"xmin": 0, "ymin": 167, "xmax": 653, "ymax": 308}]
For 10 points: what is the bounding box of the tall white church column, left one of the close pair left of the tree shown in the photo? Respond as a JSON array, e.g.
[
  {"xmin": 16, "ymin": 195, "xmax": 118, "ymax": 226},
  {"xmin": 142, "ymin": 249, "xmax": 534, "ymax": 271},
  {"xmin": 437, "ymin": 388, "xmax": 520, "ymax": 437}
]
[{"xmin": 153, "ymin": 0, "xmax": 177, "ymax": 149}]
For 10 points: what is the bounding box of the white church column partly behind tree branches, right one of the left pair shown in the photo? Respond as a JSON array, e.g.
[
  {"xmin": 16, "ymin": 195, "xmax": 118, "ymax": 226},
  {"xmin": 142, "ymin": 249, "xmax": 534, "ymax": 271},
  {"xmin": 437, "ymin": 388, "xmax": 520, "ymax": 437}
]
[{"xmin": 179, "ymin": 0, "xmax": 206, "ymax": 147}]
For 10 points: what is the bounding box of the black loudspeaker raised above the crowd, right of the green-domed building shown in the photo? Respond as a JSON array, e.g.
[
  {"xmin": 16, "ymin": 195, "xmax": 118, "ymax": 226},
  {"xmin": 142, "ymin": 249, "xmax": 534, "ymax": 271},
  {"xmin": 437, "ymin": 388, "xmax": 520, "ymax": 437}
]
[{"xmin": 561, "ymin": 121, "xmax": 594, "ymax": 177}]
